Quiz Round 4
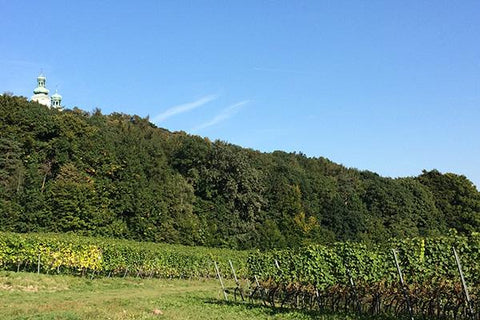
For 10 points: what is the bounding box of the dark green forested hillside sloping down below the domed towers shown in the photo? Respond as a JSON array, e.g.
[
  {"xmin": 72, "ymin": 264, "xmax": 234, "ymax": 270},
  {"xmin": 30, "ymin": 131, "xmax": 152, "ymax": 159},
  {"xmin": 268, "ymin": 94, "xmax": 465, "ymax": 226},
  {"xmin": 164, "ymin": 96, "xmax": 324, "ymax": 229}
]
[{"xmin": 0, "ymin": 95, "xmax": 480, "ymax": 248}]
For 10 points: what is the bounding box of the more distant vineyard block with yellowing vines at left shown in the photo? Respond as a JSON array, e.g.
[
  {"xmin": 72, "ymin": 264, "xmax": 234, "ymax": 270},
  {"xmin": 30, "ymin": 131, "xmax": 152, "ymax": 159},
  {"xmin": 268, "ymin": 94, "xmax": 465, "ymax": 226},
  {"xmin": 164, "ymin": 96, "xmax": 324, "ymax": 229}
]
[{"xmin": 0, "ymin": 232, "xmax": 248, "ymax": 278}]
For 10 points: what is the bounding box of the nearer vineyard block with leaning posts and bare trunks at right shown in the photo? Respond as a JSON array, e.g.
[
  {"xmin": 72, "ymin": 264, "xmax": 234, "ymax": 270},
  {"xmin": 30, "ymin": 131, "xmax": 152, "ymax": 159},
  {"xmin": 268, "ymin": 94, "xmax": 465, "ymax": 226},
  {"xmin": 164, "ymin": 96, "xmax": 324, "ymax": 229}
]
[{"xmin": 248, "ymin": 234, "xmax": 480, "ymax": 319}]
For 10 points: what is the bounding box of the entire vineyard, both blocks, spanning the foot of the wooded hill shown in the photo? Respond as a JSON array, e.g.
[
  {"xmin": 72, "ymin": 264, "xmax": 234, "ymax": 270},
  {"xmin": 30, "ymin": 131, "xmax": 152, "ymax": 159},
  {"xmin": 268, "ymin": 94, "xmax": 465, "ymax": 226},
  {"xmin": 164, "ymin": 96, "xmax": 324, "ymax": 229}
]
[{"xmin": 0, "ymin": 233, "xmax": 480, "ymax": 319}]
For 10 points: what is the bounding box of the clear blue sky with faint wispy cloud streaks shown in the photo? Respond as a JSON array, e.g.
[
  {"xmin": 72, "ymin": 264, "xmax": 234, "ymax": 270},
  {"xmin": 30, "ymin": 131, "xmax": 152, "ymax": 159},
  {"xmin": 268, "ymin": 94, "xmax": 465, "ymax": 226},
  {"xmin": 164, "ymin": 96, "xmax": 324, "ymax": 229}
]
[{"xmin": 0, "ymin": 0, "xmax": 480, "ymax": 186}]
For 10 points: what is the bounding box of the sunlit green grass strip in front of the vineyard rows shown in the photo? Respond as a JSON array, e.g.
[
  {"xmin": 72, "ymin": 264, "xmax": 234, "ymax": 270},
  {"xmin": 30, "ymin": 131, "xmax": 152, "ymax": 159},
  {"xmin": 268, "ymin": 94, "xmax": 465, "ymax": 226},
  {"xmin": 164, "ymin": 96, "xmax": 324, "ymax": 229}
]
[{"xmin": 0, "ymin": 272, "xmax": 384, "ymax": 320}]
